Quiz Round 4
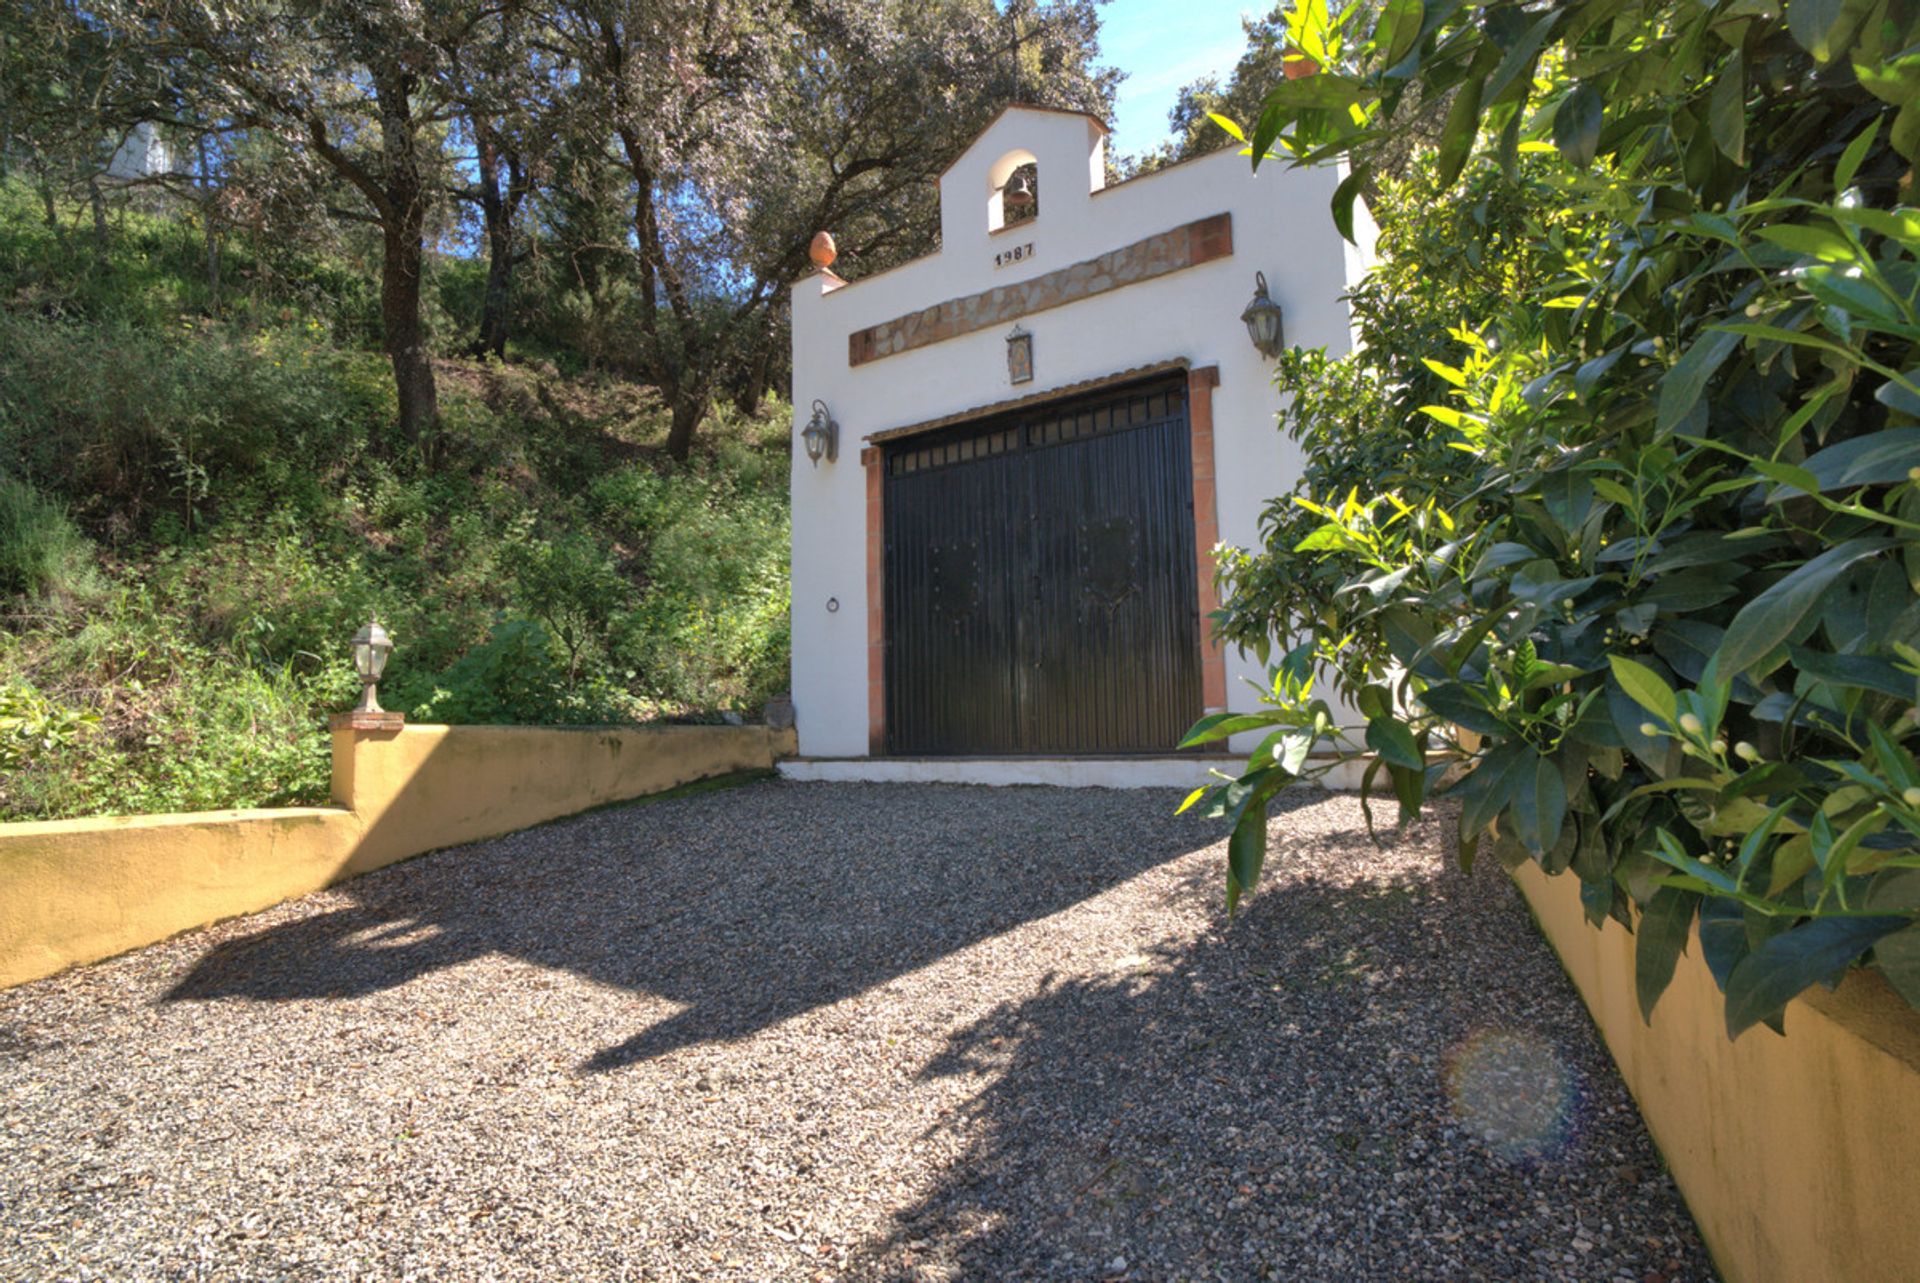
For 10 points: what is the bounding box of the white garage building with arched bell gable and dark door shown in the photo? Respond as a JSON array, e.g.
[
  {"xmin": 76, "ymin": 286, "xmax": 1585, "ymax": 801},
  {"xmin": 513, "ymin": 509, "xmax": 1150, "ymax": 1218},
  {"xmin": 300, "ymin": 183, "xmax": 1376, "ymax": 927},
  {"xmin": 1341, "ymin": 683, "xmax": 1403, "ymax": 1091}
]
[{"xmin": 789, "ymin": 108, "xmax": 1367, "ymax": 784}]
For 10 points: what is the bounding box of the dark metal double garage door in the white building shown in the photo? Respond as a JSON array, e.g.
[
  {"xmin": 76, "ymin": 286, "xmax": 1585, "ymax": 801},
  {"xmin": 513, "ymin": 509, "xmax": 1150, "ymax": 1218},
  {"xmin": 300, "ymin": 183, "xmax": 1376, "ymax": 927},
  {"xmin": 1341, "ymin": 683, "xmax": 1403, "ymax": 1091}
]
[{"xmin": 883, "ymin": 376, "xmax": 1202, "ymax": 755}]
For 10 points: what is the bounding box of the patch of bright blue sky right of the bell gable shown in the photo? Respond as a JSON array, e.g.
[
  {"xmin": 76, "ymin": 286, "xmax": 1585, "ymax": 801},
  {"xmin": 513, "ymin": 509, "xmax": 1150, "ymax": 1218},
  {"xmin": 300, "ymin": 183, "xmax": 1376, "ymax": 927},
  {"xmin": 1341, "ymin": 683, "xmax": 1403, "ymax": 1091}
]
[{"xmin": 1100, "ymin": 0, "xmax": 1273, "ymax": 156}]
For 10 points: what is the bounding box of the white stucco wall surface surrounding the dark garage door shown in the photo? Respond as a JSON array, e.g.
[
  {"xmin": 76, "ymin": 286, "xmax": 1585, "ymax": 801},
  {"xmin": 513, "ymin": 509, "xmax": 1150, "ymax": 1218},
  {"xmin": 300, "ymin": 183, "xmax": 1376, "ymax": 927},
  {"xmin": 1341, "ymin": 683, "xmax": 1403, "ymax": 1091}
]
[{"xmin": 793, "ymin": 108, "xmax": 1367, "ymax": 757}]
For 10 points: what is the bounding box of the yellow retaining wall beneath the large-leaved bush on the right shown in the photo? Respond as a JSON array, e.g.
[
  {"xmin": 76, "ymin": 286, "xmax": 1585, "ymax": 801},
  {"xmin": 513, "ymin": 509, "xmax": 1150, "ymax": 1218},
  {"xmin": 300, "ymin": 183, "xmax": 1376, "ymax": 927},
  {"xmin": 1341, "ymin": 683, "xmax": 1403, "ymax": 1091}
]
[{"xmin": 1515, "ymin": 864, "xmax": 1920, "ymax": 1283}]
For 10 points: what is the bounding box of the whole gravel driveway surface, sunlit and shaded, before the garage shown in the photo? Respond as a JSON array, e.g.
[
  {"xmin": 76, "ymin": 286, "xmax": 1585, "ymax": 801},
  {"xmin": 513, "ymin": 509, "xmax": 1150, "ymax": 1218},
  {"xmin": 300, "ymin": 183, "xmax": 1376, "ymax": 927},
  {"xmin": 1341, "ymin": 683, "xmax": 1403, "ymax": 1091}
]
[{"xmin": 0, "ymin": 782, "xmax": 1709, "ymax": 1283}]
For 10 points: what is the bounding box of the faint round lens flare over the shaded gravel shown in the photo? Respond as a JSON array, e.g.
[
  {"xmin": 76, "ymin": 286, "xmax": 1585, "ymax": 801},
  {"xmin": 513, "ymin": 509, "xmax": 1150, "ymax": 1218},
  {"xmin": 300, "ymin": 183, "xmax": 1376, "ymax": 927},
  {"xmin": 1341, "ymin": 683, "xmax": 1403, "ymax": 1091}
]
[{"xmin": 1446, "ymin": 1029, "xmax": 1574, "ymax": 1158}]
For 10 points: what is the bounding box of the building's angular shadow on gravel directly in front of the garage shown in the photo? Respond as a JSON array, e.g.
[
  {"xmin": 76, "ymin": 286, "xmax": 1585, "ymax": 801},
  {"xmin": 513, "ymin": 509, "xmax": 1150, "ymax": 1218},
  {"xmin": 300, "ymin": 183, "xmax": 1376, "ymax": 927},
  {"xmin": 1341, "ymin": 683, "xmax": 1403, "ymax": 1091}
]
[{"xmin": 167, "ymin": 782, "xmax": 1217, "ymax": 1070}]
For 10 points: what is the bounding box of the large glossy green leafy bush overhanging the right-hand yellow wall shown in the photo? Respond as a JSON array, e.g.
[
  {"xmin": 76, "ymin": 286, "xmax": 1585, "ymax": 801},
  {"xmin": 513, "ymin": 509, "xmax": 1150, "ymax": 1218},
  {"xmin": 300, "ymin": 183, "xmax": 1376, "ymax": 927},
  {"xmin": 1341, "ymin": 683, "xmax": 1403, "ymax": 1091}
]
[{"xmin": 1192, "ymin": 0, "xmax": 1920, "ymax": 1035}]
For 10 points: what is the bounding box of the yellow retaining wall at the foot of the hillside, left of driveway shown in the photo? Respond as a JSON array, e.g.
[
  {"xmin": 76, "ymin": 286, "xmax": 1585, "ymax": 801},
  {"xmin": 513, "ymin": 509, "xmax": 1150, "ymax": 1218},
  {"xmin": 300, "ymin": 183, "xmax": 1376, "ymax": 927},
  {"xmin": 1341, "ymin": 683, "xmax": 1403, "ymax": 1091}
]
[{"xmin": 0, "ymin": 726, "xmax": 793, "ymax": 987}]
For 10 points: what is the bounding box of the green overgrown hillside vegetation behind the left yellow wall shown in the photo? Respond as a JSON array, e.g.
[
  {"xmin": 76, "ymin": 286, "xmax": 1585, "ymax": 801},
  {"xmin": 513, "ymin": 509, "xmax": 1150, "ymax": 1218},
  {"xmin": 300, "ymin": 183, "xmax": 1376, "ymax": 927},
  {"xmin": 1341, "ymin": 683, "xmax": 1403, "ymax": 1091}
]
[{"xmin": 0, "ymin": 182, "xmax": 789, "ymax": 820}]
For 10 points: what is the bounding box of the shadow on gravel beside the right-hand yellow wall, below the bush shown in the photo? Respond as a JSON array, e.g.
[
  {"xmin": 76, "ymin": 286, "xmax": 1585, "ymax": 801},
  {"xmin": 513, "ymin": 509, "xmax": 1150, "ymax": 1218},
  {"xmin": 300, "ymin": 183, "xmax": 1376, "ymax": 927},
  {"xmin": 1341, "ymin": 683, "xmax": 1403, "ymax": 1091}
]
[{"xmin": 852, "ymin": 806, "xmax": 1711, "ymax": 1283}]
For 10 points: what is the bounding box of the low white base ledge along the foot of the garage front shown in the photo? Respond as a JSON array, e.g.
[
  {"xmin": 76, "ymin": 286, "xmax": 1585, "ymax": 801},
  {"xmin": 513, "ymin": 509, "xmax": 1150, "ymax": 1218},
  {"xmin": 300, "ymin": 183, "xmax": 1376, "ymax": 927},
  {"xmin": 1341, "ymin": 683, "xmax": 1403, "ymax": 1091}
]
[{"xmin": 780, "ymin": 757, "xmax": 1367, "ymax": 791}]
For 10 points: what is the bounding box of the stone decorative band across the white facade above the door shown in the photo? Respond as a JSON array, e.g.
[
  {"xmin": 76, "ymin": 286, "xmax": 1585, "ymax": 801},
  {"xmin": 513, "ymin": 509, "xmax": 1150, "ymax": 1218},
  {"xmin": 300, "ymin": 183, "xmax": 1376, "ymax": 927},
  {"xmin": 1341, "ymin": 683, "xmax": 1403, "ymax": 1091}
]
[{"xmin": 847, "ymin": 213, "xmax": 1233, "ymax": 365}]
